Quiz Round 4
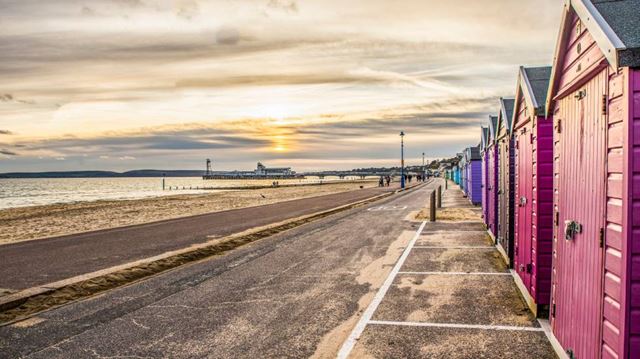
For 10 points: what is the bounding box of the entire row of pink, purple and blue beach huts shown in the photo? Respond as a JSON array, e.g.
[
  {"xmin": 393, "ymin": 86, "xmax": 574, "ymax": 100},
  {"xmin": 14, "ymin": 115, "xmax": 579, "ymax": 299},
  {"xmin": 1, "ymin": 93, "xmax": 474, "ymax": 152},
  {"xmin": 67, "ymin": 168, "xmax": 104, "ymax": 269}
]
[{"xmin": 448, "ymin": 0, "xmax": 640, "ymax": 359}]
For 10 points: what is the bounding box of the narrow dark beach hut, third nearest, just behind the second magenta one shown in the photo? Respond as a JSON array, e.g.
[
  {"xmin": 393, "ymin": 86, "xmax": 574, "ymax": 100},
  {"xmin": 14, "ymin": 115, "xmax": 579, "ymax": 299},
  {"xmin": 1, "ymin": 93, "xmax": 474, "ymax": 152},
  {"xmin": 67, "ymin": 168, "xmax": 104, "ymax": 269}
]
[{"xmin": 496, "ymin": 98, "xmax": 515, "ymax": 267}]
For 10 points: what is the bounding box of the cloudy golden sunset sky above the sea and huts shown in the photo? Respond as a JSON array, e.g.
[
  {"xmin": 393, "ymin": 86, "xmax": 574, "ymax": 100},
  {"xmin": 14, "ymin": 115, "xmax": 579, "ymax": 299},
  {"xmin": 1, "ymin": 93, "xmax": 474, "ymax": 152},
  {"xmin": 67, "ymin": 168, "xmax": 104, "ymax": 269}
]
[{"xmin": 0, "ymin": 0, "xmax": 562, "ymax": 172}]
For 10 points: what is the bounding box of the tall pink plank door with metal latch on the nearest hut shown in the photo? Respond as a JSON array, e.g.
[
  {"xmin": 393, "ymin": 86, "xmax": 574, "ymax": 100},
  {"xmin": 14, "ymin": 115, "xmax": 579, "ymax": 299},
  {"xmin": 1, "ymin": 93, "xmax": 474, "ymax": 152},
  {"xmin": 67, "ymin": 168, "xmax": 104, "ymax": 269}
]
[{"xmin": 551, "ymin": 69, "xmax": 607, "ymax": 358}]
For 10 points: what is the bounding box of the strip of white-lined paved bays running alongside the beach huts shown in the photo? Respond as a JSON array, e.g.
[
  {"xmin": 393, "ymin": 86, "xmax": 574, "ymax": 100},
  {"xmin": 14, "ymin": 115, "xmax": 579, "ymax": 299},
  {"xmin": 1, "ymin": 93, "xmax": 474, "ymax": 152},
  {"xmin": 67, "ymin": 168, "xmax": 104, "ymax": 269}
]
[{"xmin": 339, "ymin": 187, "xmax": 556, "ymax": 358}]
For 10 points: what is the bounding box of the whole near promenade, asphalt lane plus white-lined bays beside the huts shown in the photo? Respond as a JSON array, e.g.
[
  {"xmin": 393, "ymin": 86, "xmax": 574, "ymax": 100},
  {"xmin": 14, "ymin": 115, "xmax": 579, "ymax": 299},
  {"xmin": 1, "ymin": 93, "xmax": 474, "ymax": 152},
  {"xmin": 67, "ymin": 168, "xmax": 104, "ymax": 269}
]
[{"xmin": 0, "ymin": 179, "xmax": 555, "ymax": 358}]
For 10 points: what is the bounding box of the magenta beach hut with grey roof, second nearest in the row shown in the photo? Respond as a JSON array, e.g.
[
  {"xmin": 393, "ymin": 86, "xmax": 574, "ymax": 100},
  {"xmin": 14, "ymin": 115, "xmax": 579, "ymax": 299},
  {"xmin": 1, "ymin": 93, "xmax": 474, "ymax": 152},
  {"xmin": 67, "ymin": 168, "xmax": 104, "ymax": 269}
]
[{"xmin": 511, "ymin": 67, "xmax": 553, "ymax": 316}]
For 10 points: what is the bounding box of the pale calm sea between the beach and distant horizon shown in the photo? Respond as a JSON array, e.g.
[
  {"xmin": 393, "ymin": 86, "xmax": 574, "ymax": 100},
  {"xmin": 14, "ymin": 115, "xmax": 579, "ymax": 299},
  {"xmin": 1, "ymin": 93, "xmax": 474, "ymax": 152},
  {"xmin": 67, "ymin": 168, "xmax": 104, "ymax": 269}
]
[{"xmin": 0, "ymin": 177, "xmax": 354, "ymax": 209}]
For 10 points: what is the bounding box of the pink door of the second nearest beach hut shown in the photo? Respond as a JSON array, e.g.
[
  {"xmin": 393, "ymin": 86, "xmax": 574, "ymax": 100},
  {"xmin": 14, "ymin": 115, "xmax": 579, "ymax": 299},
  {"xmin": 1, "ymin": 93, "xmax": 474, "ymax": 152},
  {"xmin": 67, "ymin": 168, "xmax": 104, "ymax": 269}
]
[{"xmin": 515, "ymin": 126, "xmax": 533, "ymax": 292}]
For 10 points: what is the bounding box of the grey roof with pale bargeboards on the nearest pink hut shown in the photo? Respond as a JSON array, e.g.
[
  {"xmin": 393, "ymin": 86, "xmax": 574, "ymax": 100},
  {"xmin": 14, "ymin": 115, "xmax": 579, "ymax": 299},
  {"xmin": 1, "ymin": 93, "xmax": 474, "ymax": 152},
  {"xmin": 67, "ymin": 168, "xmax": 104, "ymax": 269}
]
[{"xmin": 546, "ymin": 0, "xmax": 640, "ymax": 116}]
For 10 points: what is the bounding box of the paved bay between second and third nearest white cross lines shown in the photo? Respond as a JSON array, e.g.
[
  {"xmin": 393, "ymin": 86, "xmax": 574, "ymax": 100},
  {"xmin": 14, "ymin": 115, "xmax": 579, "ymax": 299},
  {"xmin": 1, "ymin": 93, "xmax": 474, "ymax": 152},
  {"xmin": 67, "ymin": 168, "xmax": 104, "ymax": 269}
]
[{"xmin": 400, "ymin": 248, "xmax": 507, "ymax": 273}]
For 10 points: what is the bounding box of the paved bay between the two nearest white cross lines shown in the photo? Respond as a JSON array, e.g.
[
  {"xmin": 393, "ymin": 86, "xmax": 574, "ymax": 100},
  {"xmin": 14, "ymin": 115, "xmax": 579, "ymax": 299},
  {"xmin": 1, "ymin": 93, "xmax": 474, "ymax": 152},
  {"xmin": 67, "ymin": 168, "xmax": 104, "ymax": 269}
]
[{"xmin": 373, "ymin": 275, "xmax": 540, "ymax": 327}]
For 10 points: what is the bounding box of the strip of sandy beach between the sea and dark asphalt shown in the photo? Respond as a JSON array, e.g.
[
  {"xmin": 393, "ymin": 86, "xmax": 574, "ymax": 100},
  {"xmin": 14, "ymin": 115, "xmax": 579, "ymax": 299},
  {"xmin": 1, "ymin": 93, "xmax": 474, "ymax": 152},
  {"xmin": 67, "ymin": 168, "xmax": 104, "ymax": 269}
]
[{"xmin": 0, "ymin": 181, "xmax": 377, "ymax": 244}]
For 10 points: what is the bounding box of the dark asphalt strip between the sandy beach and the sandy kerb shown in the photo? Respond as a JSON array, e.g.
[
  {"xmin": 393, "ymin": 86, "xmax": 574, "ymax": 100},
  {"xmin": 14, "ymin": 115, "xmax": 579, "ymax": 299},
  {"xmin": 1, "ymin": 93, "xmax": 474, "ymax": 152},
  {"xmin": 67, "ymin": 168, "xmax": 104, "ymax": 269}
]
[{"xmin": 0, "ymin": 187, "xmax": 404, "ymax": 290}]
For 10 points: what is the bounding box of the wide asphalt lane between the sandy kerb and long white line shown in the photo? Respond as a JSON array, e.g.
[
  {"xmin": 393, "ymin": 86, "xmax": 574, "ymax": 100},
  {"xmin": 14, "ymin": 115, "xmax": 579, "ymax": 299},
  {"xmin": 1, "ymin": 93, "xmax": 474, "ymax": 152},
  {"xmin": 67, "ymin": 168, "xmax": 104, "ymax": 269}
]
[{"xmin": 0, "ymin": 184, "xmax": 434, "ymax": 358}]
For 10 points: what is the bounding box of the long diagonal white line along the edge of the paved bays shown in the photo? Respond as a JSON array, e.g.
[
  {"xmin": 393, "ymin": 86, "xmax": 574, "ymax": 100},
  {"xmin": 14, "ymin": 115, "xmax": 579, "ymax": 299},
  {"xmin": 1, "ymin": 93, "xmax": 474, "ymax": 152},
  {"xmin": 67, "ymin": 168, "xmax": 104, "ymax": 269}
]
[{"xmin": 338, "ymin": 221, "xmax": 427, "ymax": 359}]
